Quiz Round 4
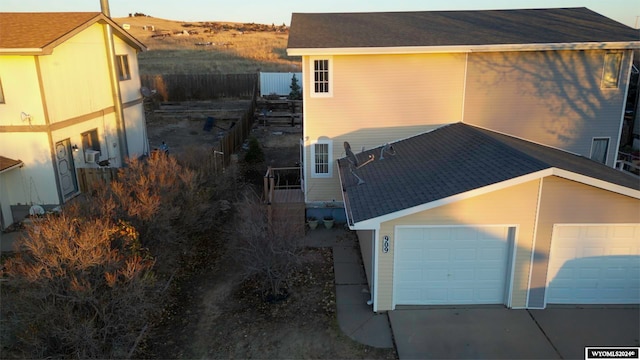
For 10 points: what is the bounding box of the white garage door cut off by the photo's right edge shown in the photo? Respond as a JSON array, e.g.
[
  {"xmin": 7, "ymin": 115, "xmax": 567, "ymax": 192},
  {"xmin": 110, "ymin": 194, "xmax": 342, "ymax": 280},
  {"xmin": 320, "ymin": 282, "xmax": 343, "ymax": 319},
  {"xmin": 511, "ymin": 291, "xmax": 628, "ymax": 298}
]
[{"xmin": 546, "ymin": 224, "xmax": 640, "ymax": 304}]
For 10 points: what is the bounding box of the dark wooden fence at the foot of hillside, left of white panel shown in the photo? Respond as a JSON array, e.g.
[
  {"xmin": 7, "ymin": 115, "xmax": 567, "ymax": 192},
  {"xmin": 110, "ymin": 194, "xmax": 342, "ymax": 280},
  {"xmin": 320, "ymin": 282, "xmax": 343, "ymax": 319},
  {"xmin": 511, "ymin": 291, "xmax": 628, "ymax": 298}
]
[{"xmin": 140, "ymin": 73, "xmax": 258, "ymax": 101}]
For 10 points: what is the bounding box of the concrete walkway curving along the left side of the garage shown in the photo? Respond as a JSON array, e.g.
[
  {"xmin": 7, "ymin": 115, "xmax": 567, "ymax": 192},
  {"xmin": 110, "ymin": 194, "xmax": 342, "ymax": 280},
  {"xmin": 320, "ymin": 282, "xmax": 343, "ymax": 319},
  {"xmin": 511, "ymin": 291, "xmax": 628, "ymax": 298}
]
[{"xmin": 305, "ymin": 226, "xmax": 394, "ymax": 348}]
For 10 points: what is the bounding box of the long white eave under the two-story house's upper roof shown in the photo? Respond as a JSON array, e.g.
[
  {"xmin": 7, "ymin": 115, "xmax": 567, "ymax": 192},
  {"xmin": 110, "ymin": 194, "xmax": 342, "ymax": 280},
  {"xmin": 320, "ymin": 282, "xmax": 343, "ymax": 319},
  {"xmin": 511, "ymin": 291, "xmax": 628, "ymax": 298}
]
[{"xmin": 287, "ymin": 41, "xmax": 640, "ymax": 56}]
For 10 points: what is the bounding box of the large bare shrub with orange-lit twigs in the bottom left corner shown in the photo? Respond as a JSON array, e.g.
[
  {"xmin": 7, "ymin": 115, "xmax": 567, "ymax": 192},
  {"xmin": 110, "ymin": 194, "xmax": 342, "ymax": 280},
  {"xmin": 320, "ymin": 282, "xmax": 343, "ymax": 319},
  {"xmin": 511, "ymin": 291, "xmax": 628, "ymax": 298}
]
[{"xmin": 1, "ymin": 207, "xmax": 156, "ymax": 358}]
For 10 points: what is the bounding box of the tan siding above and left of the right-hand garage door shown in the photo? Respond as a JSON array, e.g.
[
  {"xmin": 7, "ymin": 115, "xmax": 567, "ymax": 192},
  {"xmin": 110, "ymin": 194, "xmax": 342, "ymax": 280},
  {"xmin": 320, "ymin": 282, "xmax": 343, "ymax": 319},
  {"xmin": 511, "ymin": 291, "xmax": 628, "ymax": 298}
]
[{"xmin": 529, "ymin": 177, "xmax": 640, "ymax": 307}]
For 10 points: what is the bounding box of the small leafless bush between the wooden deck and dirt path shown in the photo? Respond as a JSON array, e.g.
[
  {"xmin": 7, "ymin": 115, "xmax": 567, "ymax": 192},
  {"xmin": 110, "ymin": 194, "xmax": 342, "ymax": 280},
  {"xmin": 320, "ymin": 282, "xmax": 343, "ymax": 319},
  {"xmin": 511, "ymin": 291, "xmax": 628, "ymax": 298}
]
[{"xmin": 235, "ymin": 194, "xmax": 302, "ymax": 298}]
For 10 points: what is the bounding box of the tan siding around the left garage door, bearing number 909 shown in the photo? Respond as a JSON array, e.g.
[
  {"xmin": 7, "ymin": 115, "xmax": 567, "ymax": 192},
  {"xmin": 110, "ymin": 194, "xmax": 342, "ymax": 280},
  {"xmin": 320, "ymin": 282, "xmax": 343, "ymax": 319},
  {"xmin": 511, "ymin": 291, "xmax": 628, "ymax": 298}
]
[{"xmin": 376, "ymin": 180, "xmax": 539, "ymax": 311}]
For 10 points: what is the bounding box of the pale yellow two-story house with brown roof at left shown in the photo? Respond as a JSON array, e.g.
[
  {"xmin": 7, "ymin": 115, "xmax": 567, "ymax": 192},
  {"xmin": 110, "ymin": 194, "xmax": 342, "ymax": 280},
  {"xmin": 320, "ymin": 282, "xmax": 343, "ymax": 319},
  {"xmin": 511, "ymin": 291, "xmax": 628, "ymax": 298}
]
[{"xmin": 0, "ymin": 12, "xmax": 148, "ymax": 228}]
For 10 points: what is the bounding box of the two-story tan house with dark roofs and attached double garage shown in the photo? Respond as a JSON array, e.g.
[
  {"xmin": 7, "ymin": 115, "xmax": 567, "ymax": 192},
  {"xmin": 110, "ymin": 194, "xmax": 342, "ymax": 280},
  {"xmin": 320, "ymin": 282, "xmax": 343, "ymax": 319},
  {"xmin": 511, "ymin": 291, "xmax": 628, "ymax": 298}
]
[{"xmin": 288, "ymin": 8, "xmax": 640, "ymax": 311}]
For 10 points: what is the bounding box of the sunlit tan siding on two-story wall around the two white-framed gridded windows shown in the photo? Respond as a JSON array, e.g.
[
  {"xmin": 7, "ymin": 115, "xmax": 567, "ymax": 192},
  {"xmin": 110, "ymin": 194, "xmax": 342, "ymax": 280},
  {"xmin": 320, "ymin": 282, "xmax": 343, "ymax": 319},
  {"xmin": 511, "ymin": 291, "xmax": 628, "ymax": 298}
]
[{"xmin": 302, "ymin": 54, "xmax": 466, "ymax": 201}]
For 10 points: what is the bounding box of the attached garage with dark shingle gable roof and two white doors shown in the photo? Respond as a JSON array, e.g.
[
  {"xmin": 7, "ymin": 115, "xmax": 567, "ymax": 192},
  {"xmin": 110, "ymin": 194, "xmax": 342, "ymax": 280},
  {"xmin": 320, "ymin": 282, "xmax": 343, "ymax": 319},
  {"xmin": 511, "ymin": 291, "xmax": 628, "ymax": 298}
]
[{"xmin": 339, "ymin": 124, "xmax": 640, "ymax": 312}]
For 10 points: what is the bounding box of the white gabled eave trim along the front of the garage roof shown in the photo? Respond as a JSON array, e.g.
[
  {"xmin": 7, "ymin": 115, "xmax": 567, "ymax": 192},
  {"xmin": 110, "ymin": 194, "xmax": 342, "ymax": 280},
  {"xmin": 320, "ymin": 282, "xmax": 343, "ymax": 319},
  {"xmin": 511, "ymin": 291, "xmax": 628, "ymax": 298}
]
[{"xmin": 349, "ymin": 167, "xmax": 640, "ymax": 230}]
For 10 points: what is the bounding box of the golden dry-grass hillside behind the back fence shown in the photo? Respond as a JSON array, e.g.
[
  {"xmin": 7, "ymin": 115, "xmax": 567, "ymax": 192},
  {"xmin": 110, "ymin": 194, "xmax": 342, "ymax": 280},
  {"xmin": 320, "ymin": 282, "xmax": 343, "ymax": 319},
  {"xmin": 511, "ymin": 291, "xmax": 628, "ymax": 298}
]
[{"xmin": 114, "ymin": 16, "xmax": 301, "ymax": 75}]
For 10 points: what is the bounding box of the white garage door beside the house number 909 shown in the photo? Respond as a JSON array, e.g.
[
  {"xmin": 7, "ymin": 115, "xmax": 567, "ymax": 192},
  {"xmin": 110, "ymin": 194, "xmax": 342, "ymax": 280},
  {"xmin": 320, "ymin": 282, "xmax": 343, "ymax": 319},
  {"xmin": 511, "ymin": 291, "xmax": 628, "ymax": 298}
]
[{"xmin": 394, "ymin": 226, "xmax": 511, "ymax": 305}]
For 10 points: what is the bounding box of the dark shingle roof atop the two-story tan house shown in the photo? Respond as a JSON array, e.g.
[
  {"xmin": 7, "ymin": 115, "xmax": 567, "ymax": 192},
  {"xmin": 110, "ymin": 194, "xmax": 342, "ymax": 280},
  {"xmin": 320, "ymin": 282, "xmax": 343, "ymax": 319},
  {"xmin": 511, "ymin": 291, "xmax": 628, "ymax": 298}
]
[{"xmin": 287, "ymin": 8, "xmax": 640, "ymax": 49}]
